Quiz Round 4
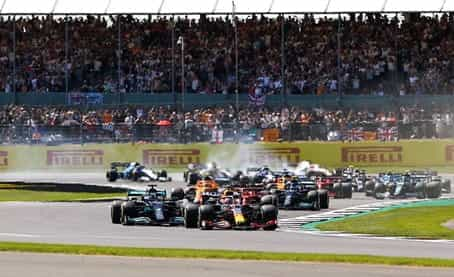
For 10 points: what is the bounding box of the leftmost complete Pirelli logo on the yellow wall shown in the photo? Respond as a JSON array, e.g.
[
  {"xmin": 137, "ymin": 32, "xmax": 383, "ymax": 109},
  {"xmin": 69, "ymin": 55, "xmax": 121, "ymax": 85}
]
[{"xmin": 47, "ymin": 150, "xmax": 104, "ymax": 167}]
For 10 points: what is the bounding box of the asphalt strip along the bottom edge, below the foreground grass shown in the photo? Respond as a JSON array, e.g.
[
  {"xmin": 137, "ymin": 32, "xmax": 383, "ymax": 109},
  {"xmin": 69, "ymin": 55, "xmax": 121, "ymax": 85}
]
[{"xmin": 0, "ymin": 253, "xmax": 454, "ymax": 277}]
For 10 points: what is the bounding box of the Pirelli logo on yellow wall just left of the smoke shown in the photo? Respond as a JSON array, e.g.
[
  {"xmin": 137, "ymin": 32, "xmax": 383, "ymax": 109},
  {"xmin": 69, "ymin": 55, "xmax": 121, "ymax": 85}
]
[{"xmin": 143, "ymin": 149, "xmax": 200, "ymax": 167}]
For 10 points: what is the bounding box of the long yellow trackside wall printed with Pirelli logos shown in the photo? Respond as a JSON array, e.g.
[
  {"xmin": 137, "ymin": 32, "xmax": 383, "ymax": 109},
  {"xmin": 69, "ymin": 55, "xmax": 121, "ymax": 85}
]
[{"xmin": 0, "ymin": 140, "xmax": 454, "ymax": 171}]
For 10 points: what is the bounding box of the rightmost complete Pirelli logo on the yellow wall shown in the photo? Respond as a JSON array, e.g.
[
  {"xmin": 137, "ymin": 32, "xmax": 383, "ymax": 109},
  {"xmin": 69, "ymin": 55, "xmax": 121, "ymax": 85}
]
[{"xmin": 341, "ymin": 146, "xmax": 402, "ymax": 164}]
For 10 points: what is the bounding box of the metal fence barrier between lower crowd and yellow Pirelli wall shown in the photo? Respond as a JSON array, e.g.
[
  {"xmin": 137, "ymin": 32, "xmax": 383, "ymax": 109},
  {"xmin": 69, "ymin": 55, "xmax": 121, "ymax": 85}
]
[{"xmin": 0, "ymin": 121, "xmax": 454, "ymax": 145}]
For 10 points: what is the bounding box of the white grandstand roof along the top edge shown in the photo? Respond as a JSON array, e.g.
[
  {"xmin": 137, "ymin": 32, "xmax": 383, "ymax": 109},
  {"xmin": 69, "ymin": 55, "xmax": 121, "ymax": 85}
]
[{"xmin": 0, "ymin": 0, "xmax": 454, "ymax": 15}]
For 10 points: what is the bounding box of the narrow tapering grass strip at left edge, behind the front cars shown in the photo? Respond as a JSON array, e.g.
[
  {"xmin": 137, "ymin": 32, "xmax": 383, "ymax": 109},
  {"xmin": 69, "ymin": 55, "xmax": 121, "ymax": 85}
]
[{"xmin": 0, "ymin": 189, "xmax": 125, "ymax": 202}]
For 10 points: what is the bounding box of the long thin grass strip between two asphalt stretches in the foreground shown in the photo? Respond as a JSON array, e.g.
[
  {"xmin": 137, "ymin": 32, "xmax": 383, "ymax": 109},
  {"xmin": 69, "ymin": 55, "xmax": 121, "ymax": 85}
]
[{"xmin": 0, "ymin": 242, "xmax": 454, "ymax": 267}]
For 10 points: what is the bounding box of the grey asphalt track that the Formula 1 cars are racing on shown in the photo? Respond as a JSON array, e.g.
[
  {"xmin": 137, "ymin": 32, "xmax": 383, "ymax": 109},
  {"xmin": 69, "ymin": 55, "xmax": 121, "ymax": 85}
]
[{"xmin": 0, "ymin": 170, "xmax": 454, "ymax": 258}]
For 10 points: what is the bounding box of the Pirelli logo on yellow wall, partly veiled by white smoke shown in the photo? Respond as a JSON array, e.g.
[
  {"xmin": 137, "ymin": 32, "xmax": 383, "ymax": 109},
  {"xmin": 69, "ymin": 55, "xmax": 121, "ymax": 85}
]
[{"xmin": 242, "ymin": 147, "xmax": 301, "ymax": 164}]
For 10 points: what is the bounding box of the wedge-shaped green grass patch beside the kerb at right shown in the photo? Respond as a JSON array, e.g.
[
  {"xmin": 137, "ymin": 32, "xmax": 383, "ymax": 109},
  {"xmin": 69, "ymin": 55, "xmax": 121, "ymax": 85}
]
[{"xmin": 317, "ymin": 206, "xmax": 454, "ymax": 240}]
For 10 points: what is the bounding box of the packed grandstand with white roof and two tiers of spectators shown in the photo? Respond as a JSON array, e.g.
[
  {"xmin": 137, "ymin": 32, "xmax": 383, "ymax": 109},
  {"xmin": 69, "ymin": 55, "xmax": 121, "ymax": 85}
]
[{"xmin": 0, "ymin": 0, "xmax": 454, "ymax": 142}]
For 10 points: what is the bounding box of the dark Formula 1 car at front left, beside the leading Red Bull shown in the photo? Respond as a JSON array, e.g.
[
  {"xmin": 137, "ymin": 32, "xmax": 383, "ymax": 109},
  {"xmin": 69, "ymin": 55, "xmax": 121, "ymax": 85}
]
[{"xmin": 110, "ymin": 185, "xmax": 184, "ymax": 226}]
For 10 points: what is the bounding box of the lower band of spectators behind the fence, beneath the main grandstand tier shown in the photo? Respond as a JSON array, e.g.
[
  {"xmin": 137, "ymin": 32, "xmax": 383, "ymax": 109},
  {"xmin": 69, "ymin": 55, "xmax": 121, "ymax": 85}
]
[{"xmin": 0, "ymin": 103, "xmax": 454, "ymax": 143}]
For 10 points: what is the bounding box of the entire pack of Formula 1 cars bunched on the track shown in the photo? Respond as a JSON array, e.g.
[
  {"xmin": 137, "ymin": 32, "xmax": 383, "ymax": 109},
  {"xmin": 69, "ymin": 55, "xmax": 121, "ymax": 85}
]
[{"xmin": 106, "ymin": 162, "xmax": 451, "ymax": 230}]
